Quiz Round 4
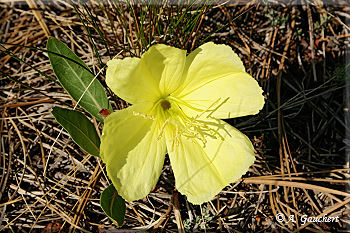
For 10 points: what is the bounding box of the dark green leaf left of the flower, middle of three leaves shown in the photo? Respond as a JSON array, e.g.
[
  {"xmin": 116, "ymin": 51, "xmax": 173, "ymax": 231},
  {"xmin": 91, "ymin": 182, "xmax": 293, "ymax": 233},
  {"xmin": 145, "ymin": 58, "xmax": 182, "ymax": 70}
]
[{"xmin": 51, "ymin": 107, "xmax": 100, "ymax": 156}]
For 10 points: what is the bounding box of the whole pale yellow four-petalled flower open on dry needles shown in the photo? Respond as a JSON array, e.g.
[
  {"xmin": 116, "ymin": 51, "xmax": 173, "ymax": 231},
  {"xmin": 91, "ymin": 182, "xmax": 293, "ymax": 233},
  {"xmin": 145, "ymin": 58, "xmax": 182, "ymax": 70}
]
[{"xmin": 101, "ymin": 42, "xmax": 264, "ymax": 204}]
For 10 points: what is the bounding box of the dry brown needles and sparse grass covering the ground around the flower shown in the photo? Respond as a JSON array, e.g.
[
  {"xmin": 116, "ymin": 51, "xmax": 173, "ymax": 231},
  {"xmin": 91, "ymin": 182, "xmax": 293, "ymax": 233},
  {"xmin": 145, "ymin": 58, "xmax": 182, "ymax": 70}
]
[{"xmin": 0, "ymin": 0, "xmax": 350, "ymax": 232}]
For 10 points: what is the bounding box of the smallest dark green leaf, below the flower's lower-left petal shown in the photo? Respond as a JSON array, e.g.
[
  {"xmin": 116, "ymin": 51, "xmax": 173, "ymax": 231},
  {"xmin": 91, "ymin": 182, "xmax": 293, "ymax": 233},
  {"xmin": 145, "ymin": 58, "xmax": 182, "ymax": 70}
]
[{"xmin": 100, "ymin": 184, "xmax": 126, "ymax": 226}]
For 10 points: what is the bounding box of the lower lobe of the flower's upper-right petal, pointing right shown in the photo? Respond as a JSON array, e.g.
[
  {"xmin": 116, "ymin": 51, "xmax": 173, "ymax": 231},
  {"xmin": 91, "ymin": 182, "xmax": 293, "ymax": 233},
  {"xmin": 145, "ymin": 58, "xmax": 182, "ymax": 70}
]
[{"xmin": 180, "ymin": 72, "xmax": 265, "ymax": 119}]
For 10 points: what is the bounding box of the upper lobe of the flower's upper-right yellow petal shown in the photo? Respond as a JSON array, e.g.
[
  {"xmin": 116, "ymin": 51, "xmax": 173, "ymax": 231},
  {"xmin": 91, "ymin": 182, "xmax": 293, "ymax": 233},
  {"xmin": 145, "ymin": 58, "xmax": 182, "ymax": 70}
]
[{"xmin": 175, "ymin": 42, "xmax": 245, "ymax": 95}]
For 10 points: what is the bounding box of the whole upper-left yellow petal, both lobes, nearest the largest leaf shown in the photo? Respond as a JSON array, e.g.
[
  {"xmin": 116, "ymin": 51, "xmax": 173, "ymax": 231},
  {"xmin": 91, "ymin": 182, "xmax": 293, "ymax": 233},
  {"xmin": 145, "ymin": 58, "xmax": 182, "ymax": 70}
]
[{"xmin": 106, "ymin": 44, "xmax": 186, "ymax": 104}]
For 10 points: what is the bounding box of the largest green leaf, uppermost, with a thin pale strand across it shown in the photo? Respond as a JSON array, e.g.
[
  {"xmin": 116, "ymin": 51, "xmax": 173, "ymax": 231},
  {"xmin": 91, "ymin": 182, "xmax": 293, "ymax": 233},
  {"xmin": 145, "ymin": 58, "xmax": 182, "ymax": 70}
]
[{"xmin": 47, "ymin": 38, "xmax": 111, "ymax": 122}]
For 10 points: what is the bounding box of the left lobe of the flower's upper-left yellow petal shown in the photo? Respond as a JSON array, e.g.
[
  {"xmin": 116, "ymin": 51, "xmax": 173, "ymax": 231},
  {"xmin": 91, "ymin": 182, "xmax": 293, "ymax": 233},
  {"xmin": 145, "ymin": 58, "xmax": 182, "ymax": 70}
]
[{"xmin": 106, "ymin": 57, "xmax": 160, "ymax": 104}]
